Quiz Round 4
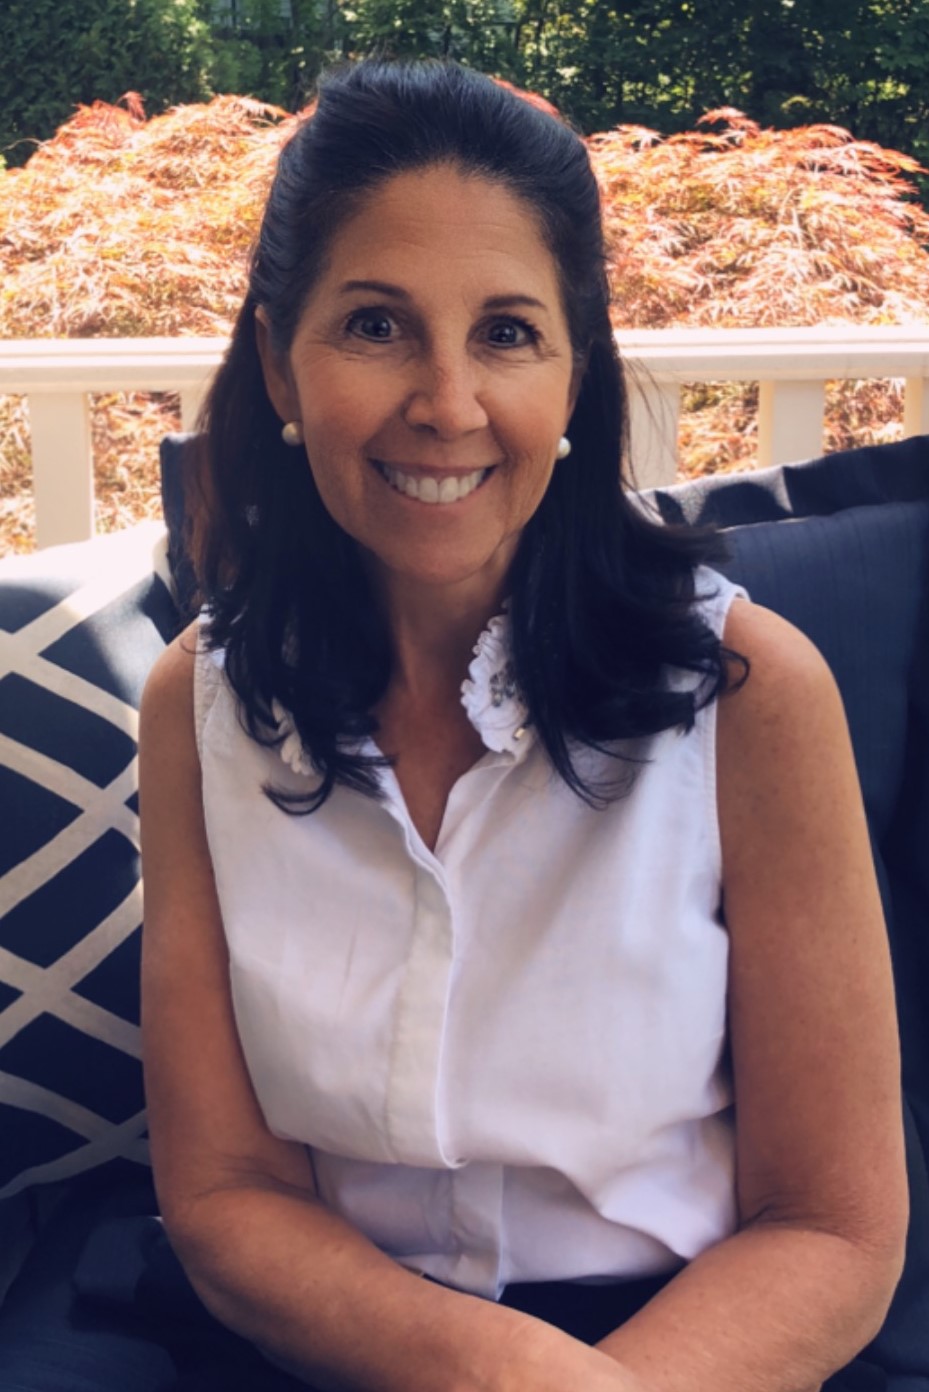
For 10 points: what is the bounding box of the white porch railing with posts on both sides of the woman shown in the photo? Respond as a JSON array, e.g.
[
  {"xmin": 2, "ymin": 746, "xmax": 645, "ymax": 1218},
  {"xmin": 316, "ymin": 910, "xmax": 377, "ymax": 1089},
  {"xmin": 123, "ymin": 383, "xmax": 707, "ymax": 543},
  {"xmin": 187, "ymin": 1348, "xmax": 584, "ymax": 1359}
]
[{"xmin": 0, "ymin": 326, "xmax": 929, "ymax": 546}]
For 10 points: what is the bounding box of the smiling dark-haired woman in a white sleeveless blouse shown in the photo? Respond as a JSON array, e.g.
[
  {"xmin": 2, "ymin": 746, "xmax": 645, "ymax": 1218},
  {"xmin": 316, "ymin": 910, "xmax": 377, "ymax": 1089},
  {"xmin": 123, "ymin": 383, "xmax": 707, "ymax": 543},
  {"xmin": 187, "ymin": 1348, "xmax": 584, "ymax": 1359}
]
[{"xmin": 142, "ymin": 63, "xmax": 905, "ymax": 1392}]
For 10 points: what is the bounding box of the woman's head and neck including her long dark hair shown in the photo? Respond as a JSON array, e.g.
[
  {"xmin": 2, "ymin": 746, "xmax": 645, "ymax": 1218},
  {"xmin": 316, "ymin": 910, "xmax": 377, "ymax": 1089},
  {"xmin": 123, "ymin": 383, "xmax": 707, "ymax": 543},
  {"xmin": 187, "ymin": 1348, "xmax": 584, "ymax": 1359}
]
[{"xmin": 189, "ymin": 63, "xmax": 727, "ymax": 812}]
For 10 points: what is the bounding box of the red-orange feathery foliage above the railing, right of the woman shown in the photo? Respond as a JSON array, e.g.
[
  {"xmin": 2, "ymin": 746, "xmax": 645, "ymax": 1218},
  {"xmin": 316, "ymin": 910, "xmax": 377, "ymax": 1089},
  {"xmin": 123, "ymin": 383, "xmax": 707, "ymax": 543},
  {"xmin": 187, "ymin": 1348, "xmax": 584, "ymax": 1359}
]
[{"xmin": 588, "ymin": 109, "xmax": 929, "ymax": 329}]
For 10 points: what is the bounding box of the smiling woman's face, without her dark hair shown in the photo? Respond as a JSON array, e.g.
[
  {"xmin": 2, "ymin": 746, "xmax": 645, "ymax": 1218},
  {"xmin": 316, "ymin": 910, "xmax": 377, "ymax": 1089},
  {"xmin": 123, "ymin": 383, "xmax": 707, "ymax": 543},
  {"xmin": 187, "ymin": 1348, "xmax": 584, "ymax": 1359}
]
[{"xmin": 259, "ymin": 167, "xmax": 577, "ymax": 599}]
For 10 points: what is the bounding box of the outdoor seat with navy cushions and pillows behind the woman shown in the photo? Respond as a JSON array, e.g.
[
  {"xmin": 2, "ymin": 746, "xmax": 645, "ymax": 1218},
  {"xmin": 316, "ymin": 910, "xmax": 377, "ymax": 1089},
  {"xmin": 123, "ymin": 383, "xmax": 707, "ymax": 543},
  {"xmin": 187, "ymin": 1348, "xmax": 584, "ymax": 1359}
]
[{"xmin": 0, "ymin": 436, "xmax": 929, "ymax": 1392}]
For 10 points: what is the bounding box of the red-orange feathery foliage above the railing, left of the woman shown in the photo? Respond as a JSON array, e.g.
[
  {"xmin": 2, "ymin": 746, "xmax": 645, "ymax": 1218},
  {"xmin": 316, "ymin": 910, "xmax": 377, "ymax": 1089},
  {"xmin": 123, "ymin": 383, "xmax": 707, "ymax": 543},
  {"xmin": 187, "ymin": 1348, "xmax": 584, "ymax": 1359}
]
[{"xmin": 0, "ymin": 96, "xmax": 295, "ymax": 338}]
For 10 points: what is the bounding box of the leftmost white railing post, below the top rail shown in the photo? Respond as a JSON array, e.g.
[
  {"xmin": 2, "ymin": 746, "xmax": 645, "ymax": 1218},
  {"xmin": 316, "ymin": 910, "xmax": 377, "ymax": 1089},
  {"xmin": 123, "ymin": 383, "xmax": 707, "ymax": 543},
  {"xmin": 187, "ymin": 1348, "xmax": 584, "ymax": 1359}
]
[{"xmin": 28, "ymin": 391, "xmax": 93, "ymax": 547}]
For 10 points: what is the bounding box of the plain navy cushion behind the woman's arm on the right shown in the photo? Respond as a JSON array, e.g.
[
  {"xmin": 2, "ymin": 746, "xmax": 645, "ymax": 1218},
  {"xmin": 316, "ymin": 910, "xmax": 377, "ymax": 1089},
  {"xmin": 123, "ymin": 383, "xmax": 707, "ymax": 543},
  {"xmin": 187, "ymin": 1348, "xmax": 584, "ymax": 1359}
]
[{"xmin": 650, "ymin": 436, "xmax": 929, "ymax": 1392}]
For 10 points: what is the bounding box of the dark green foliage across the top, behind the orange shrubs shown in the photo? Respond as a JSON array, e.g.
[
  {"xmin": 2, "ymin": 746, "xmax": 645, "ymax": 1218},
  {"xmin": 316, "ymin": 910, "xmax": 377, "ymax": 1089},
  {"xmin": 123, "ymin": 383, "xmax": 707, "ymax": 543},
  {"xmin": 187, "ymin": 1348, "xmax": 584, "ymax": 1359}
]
[{"xmin": 0, "ymin": 0, "xmax": 929, "ymax": 196}]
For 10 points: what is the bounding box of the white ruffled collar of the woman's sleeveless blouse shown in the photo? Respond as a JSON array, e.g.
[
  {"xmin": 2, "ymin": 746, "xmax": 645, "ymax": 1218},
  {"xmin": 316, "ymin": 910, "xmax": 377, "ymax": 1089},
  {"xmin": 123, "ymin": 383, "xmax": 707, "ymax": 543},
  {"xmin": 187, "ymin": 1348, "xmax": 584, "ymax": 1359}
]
[{"xmin": 272, "ymin": 604, "xmax": 531, "ymax": 778}]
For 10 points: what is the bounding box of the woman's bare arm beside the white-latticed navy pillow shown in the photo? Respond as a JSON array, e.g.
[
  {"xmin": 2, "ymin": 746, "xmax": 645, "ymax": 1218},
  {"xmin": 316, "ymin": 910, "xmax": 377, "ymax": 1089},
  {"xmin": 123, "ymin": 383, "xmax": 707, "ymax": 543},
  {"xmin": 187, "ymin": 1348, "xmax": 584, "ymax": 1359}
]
[{"xmin": 141, "ymin": 631, "xmax": 637, "ymax": 1392}]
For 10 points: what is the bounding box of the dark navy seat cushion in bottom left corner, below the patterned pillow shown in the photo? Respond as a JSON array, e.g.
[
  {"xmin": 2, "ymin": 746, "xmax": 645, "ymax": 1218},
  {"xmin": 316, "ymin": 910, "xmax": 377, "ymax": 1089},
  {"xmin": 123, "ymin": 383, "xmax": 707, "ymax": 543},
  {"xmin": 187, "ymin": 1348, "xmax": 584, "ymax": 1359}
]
[{"xmin": 0, "ymin": 1161, "xmax": 312, "ymax": 1392}]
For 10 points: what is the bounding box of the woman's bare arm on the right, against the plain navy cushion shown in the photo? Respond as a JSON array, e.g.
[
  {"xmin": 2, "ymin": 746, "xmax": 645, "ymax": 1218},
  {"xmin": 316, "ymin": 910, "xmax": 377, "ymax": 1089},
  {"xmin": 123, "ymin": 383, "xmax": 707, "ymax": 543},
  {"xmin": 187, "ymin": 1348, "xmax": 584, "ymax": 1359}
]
[{"xmin": 599, "ymin": 603, "xmax": 907, "ymax": 1392}]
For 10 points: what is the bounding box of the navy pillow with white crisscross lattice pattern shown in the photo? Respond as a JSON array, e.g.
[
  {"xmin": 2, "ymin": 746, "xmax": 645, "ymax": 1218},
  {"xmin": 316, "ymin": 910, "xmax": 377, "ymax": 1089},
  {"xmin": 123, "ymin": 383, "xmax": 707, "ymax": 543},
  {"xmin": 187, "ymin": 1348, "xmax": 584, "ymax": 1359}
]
[{"xmin": 0, "ymin": 523, "xmax": 177, "ymax": 1199}]
